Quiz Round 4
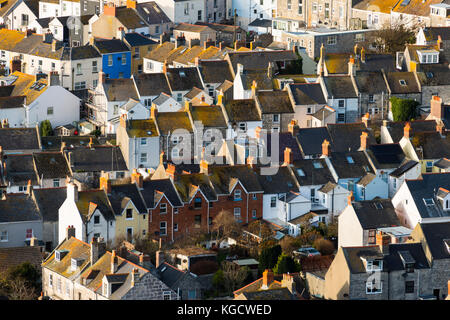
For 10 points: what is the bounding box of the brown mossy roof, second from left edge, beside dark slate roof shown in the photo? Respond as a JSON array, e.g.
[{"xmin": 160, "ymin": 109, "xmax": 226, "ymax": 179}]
[{"xmin": 33, "ymin": 152, "xmax": 71, "ymax": 179}]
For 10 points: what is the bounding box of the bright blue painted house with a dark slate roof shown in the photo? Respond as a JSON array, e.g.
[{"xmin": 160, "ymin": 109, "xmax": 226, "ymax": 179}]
[{"xmin": 94, "ymin": 39, "xmax": 131, "ymax": 79}]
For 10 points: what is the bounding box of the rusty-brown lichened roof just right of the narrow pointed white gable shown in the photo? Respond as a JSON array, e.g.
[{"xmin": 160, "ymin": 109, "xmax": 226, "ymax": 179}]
[{"xmin": 256, "ymin": 91, "xmax": 294, "ymax": 114}]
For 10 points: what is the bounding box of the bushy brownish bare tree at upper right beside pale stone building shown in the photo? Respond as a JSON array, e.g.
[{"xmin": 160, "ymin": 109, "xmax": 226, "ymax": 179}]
[{"xmin": 374, "ymin": 23, "xmax": 416, "ymax": 54}]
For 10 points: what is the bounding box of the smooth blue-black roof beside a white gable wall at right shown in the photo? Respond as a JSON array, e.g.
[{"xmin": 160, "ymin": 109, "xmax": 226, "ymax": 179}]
[{"xmin": 366, "ymin": 143, "xmax": 405, "ymax": 169}]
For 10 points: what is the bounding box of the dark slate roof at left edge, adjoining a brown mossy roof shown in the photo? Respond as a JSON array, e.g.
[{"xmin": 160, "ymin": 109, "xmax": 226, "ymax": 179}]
[{"xmin": 3, "ymin": 154, "xmax": 37, "ymax": 186}]
